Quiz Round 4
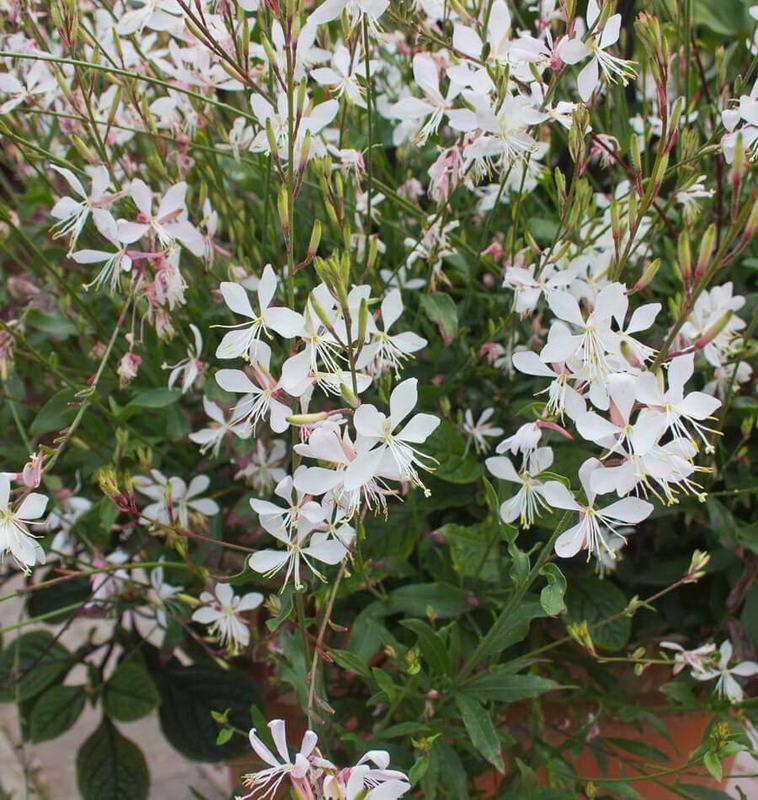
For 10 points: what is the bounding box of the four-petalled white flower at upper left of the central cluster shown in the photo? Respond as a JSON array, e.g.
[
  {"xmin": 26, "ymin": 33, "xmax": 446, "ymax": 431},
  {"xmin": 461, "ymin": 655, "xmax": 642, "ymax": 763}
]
[{"xmin": 216, "ymin": 264, "xmax": 303, "ymax": 358}]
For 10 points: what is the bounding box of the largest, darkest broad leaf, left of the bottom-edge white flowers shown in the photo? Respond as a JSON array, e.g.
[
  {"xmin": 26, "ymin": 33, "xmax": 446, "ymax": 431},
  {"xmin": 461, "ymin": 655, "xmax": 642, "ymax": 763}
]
[{"xmin": 153, "ymin": 665, "xmax": 259, "ymax": 763}]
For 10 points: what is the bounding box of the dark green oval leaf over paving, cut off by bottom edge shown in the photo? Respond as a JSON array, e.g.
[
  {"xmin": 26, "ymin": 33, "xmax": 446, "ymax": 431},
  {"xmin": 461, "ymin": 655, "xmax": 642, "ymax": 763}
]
[{"xmin": 76, "ymin": 719, "xmax": 150, "ymax": 800}]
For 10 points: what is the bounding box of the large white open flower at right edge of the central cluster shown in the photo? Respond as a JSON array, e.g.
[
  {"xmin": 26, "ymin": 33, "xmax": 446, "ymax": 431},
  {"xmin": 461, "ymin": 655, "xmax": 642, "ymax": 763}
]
[{"xmin": 354, "ymin": 378, "xmax": 440, "ymax": 488}]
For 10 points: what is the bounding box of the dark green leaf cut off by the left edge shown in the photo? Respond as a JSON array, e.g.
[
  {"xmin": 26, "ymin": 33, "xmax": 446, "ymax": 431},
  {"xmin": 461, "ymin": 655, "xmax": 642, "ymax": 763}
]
[{"xmin": 0, "ymin": 631, "xmax": 73, "ymax": 703}]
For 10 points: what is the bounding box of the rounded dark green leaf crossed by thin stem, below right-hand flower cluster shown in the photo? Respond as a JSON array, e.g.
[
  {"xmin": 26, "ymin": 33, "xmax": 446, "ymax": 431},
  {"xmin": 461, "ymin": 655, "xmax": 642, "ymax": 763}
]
[{"xmin": 566, "ymin": 578, "xmax": 632, "ymax": 650}]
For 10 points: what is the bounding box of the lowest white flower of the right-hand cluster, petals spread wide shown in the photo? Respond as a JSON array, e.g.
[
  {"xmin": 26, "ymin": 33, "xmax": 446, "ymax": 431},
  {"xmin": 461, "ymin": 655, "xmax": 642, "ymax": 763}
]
[{"xmin": 544, "ymin": 458, "xmax": 653, "ymax": 558}]
